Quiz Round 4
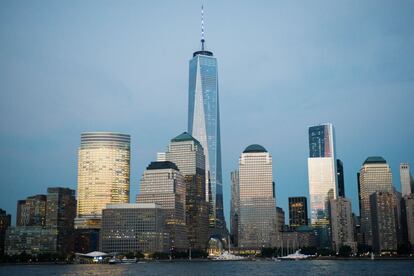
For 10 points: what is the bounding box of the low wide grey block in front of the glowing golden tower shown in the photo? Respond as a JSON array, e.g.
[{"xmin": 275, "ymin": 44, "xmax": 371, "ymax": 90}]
[{"xmin": 100, "ymin": 203, "xmax": 169, "ymax": 253}]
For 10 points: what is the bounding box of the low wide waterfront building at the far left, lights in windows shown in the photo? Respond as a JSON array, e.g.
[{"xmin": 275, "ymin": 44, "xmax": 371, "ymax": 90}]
[{"xmin": 5, "ymin": 226, "xmax": 58, "ymax": 255}]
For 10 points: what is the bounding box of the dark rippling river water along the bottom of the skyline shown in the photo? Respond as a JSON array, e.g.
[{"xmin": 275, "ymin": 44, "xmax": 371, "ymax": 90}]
[{"xmin": 0, "ymin": 260, "xmax": 414, "ymax": 276}]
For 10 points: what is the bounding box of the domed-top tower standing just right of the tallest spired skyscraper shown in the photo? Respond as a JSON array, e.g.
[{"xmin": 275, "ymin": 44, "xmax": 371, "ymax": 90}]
[{"xmin": 239, "ymin": 144, "xmax": 277, "ymax": 249}]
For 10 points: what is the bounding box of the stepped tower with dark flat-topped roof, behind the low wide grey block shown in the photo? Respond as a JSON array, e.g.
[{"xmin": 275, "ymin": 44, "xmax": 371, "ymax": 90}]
[{"xmin": 137, "ymin": 161, "xmax": 188, "ymax": 251}]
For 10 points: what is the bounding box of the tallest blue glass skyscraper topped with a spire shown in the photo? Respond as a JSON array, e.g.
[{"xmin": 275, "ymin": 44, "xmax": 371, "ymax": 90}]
[{"xmin": 188, "ymin": 7, "xmax": 226, "ymax": 229}]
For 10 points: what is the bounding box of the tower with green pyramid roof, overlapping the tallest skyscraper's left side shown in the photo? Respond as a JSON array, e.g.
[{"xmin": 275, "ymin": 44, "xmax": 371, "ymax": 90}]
[{"xmin": 165, "ymin": 132, "xmax": 209, "ymax": 250}]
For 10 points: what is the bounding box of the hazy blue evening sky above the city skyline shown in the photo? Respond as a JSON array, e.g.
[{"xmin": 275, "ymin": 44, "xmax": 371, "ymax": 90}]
[{"xmin": 0, "ymin": 0, "xmax": 414, "ymax": 224}]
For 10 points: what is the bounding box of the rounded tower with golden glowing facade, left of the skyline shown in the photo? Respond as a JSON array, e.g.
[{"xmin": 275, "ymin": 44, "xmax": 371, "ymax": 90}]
[{"xmin": 75, "ymin": 132, "xmax": 130, "ymax": 229}]
